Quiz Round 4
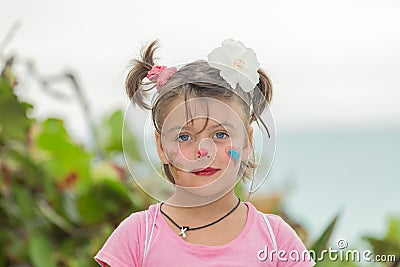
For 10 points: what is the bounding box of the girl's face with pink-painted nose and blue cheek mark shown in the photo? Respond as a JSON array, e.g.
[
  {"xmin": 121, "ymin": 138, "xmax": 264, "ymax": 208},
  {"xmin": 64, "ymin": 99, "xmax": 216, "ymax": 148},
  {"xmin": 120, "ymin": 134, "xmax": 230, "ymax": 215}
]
[{"xmin": 156, "ymin": 98, "xmax": 252, "ymax": 196}]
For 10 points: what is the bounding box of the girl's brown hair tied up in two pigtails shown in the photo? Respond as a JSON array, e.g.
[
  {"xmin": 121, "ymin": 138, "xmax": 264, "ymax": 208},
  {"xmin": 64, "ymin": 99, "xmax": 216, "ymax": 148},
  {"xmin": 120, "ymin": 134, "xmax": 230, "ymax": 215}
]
[{"xmin": 125, "ymin": 40, "xmax": 272, "ymax": 183}]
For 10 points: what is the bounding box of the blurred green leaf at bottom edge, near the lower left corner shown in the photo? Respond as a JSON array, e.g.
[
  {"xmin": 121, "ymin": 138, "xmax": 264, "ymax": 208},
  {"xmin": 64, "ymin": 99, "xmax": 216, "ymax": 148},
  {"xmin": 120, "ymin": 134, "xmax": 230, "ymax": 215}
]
[{"xmin": 29, "ymin": 233, "xmax": 56, "ymax": 267}]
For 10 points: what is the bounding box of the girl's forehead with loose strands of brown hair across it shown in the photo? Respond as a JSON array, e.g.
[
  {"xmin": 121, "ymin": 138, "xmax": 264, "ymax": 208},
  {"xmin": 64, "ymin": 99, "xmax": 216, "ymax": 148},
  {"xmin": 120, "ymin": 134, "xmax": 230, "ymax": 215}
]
[{"xmin": 162, "ymin": 97, "xmax": 243, "ymax": 131}]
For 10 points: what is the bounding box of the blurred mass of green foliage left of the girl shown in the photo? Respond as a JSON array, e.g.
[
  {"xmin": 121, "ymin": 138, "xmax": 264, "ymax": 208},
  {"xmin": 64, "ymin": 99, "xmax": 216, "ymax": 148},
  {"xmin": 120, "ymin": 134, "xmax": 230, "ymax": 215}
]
[{"xmin": 0, "ymin": 72, "xmax": 152, "ymax": 267}]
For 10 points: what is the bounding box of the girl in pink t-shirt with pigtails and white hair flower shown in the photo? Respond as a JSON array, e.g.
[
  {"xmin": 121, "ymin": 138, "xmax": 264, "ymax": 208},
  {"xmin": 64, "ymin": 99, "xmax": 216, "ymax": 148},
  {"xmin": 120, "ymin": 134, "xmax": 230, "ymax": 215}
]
[{"xmin": 95, "ymin": 39, "xmax": 314, "ymax": 267}]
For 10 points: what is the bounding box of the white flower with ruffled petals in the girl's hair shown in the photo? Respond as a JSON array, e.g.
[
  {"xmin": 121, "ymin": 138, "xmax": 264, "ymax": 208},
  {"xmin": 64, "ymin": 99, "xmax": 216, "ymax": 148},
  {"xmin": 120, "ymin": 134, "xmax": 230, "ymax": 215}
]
[{"xmin": 207, "ymin": 39, "xmax": 260, "ymax": 92}]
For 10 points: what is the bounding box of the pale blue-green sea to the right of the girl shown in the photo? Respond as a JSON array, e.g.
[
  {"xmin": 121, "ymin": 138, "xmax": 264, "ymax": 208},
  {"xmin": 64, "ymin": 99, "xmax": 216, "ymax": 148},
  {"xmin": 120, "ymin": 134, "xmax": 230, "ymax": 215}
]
[{"xmin": 257, "ymin": 127, "xmax": 400, "ymax": 250}]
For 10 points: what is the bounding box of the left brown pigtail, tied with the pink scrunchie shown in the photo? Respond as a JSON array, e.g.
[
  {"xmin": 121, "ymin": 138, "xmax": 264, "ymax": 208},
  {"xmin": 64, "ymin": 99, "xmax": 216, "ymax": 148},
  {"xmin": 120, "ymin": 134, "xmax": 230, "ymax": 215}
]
[{"xmin": 125, "ymin": 40, "xmax": 158, "ymax": 109}]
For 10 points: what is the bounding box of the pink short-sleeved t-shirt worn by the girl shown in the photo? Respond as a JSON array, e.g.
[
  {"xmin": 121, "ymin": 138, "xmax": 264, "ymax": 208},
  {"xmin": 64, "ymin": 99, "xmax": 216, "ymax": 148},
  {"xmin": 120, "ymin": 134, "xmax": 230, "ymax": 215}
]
[{"xmin": 95, "ymin": 202, "xmax": 315, "ymax": 267}]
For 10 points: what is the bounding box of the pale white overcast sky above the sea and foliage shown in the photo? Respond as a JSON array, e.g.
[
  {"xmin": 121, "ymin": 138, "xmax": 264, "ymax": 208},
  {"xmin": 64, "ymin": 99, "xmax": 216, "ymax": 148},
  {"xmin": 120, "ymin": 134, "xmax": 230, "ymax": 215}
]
[{"xmin": 0, "ymin": 0, "xmax": 400, "ymax": 249}]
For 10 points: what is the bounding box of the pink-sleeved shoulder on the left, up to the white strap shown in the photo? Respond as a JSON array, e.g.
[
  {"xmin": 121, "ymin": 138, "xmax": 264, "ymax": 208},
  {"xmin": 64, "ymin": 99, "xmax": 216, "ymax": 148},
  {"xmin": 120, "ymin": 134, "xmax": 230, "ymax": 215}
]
[{"xmin": 95, "ymin": 205, "xmax": 160, "ymax": 267}]
